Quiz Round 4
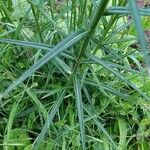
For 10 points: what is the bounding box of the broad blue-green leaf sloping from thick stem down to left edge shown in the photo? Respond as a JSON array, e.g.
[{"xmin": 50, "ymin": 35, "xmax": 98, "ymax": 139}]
[{"xmin": 0, "ymin": 30, "xmax": 87, "ymax": 98}]
